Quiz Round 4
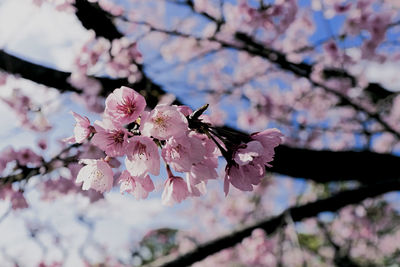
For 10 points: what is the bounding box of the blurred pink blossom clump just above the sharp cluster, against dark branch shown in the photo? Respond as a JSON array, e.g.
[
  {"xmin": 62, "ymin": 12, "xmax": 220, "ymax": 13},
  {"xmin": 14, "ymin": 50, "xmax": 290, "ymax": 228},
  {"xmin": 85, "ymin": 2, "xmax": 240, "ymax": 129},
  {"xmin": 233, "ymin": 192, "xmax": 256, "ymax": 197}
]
[{"xmin": 68, "ymin": 31, "xmax": 143, "ymax": 113}]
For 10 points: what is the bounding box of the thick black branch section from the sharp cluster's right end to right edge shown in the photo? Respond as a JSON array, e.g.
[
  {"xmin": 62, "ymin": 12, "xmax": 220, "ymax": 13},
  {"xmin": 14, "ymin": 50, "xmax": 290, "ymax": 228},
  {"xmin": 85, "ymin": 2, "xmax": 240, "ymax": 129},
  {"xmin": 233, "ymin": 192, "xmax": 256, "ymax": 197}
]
[{"xmin": 267, "ymin": 145, "xmax": 400, "ymax": 183}]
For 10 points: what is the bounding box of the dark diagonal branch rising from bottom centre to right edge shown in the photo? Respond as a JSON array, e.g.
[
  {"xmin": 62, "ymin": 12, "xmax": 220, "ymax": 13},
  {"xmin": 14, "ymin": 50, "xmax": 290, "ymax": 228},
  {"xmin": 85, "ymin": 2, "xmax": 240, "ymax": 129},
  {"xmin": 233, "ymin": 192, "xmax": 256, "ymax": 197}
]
[{"xmin": 148, "ymin": 180, "xmax": 400, "ymax": 267}]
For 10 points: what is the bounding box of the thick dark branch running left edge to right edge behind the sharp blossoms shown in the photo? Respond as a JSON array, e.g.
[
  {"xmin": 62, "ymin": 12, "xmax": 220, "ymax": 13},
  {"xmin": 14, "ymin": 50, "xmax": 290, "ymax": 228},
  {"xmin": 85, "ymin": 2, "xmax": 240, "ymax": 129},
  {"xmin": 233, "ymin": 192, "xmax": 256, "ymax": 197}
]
[{"xmin": 0, "ymin": 51, "xmax": 400, "ymax": 183}]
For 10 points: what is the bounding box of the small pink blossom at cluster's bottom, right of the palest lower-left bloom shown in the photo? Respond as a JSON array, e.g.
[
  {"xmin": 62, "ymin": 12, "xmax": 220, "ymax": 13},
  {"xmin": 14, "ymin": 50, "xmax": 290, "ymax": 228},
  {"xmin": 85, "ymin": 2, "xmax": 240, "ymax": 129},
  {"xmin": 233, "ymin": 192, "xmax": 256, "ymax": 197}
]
[{"xmin": 119, "ymin": 171, "xmax": 154, "ymax": 199}]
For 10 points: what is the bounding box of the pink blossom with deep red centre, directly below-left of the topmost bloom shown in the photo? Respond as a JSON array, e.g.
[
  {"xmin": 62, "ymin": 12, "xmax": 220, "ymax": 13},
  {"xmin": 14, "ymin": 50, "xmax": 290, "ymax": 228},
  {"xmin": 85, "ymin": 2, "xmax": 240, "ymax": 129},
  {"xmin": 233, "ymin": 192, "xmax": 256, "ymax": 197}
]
[{"xmin": 91, "ymin": 119, "xmax": 128, "ymax": 157}]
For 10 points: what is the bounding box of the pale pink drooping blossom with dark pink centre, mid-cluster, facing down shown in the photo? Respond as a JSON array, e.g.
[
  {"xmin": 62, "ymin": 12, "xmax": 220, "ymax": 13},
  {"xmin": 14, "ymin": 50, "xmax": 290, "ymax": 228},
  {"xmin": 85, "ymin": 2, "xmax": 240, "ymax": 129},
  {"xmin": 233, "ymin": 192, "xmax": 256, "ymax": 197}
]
[{"xmin": 125, "ymin": 136, "xmax": 160, "ymax": 176}]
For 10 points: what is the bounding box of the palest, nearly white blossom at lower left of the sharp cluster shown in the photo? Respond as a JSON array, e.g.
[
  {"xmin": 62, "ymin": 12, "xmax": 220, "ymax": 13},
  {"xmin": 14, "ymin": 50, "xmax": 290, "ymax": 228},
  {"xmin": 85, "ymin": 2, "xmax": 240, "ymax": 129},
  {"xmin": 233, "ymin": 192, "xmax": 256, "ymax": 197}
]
[{"xmin": 76, "ymin": 159, "xmax": 114, "ymax": 193}]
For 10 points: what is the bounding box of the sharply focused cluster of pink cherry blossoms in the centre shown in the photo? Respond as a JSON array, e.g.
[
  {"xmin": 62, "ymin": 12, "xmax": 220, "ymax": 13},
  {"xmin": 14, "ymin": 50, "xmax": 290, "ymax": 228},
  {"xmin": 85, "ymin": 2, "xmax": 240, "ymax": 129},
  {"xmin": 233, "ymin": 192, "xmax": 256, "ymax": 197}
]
[{"xmin": 69, "ymin": 86, "xmax": 282, "ymax": 205}]
